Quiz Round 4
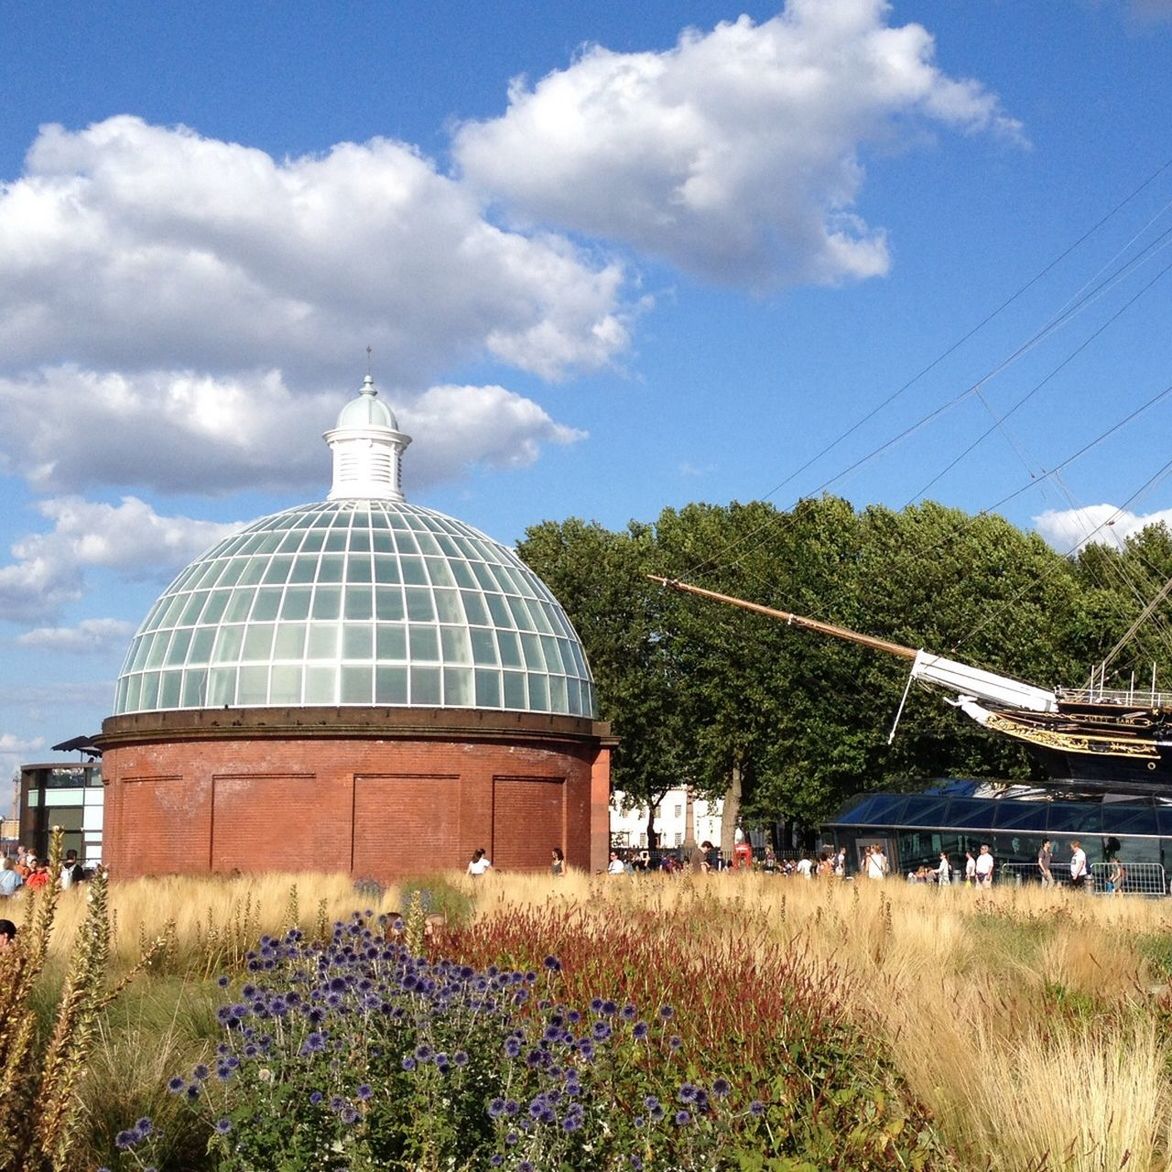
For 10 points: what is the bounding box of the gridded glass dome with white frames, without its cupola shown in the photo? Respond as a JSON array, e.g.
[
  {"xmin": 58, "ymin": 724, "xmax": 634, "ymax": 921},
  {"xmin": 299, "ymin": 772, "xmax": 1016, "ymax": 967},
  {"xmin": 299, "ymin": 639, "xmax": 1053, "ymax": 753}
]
[{"xmin": 115, "ymin": 499, "xmax": 595, "ymax": 717}]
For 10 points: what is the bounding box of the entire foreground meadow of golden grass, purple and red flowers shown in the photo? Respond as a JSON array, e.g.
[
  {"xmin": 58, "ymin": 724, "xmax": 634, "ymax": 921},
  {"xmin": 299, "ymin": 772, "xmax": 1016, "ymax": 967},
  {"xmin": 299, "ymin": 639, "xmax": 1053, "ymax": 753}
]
[{"xmin": 0, "ymin": 839, "xmax": 1172, "ymax": 1172}]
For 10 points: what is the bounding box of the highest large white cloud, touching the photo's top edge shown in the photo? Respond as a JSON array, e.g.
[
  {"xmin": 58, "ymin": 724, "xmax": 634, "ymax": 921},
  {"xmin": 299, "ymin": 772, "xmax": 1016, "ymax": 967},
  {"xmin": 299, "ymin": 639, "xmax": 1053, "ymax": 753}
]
[{"xmin": 455, "ymin": 0, "xmax": 1020, "ymax": 287}]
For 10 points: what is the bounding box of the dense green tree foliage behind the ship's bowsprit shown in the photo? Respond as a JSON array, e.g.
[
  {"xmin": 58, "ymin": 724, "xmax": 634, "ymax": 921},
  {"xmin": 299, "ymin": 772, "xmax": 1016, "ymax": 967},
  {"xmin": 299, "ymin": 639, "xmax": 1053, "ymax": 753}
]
[{"xmin": 519, "ymin": 496, "xmax": 1172, "ymax": 823}]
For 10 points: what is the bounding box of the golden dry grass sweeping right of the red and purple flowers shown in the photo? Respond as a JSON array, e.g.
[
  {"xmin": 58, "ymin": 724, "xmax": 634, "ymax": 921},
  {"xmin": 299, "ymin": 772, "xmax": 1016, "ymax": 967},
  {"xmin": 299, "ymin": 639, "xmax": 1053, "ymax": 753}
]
[{"xmin": 450, "ymin": 875, "xmax": 1172, "ymax": 1172}]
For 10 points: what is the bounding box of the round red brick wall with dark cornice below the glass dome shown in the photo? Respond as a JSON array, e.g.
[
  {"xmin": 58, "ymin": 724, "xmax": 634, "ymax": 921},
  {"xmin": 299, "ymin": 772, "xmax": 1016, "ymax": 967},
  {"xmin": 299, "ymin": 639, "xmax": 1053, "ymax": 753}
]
[{"xmin": 103, "ymin": 714, "xmax": 609, "ymax": 879}]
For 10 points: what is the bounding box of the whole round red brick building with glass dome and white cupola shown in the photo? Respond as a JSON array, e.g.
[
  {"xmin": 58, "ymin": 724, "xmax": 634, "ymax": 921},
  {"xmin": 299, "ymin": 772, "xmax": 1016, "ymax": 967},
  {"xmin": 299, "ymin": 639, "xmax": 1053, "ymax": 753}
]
[{"xmin": 98, "ymin": 375, "xmax": 613, "ymax": 879}]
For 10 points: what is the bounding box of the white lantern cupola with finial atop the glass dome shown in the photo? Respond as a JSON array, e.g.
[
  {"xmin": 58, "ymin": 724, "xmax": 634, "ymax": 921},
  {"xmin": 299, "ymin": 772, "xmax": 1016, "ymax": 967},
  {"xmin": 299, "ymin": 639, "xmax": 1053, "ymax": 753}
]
[{"xmin": 325, "ymin": 375, "xmax": 411, "ymax": 500}]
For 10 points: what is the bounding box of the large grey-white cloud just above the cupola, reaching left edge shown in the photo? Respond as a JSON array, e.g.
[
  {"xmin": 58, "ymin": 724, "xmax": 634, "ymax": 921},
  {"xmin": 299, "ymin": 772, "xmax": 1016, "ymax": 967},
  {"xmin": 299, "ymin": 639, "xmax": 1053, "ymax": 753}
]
[{"xmin": 0, "ymin": 115, "xmax": 628, "ymax": 389}]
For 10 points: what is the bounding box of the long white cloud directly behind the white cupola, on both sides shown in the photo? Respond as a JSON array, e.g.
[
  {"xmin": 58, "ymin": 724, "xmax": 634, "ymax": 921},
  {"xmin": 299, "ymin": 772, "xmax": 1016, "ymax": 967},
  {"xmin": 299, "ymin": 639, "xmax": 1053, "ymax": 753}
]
[{"xmin": 0, "ymin": 367, "xmax": 584, "ymax": 499}]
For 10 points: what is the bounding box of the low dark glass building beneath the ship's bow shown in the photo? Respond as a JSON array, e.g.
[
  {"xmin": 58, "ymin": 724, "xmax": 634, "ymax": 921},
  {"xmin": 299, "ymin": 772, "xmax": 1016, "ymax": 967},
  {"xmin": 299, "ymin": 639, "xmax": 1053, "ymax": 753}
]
[{"xmin": 823, "ymin": 782, "xmax": 1172, "ymax": 874}]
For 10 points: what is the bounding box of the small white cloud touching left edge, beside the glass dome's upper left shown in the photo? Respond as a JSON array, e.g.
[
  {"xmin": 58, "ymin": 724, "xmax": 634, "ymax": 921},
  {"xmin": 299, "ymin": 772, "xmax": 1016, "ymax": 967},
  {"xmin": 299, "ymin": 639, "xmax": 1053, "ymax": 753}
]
[{"xmin": 0, "ymin": 497, "xmax": 244, "ymax": 622}]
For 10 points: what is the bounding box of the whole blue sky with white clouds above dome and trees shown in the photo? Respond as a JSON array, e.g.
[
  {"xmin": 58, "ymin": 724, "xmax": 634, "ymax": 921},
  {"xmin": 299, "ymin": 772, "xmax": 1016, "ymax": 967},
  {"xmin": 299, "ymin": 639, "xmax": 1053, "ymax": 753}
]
[{"xmin": 0, "ymin": 0, "xmax": 1172, "ymax": 792}]
